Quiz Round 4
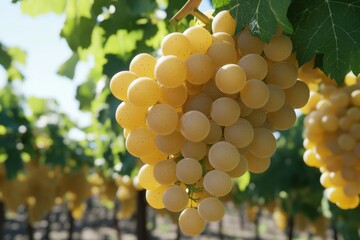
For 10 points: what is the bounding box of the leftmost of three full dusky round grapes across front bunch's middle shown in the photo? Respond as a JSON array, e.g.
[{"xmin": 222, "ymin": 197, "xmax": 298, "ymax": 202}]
[{"xmin": 146, "ymin": 103, "xmax": 178, "ymax": 135}]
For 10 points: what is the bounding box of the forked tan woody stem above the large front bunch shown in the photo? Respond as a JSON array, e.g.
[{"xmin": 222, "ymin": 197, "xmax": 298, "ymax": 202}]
[{"xmin": 170, "ymin": 0, "xmax": 210, "ymax": 24}]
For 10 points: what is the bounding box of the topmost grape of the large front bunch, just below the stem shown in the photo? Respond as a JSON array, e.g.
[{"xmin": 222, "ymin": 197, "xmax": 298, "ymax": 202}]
[{"xmin": 211, "ymin": 10, "xmax": 236, "ymax": 35}]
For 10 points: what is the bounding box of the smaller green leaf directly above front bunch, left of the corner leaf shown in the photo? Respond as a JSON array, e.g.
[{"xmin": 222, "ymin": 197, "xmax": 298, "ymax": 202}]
[{"xmin": 221, "ymin": 0, "xmax": 293, "ymax": 42}]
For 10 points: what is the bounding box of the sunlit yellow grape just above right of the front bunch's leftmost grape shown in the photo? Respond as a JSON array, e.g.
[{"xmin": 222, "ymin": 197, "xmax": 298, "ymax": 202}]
[{"xmin": 129, "ymin": 53, "xmax": 156, "ymax": 79}]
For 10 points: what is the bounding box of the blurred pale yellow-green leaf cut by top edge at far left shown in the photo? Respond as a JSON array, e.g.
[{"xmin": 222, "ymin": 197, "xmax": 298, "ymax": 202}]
[{"xmin": 21, "ymin": 0, "xmax": 66, "ymax": 16}]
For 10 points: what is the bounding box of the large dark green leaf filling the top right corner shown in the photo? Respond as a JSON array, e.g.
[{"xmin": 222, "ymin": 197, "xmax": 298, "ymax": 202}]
[{"xmin": 289, "ymin": 0, "xmax": 360, "ymax": 84}]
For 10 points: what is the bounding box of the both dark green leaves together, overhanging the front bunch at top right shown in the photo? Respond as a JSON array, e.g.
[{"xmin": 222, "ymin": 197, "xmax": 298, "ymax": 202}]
[{"xmin": 213, "ymin": 0, "xmax": 360, "ymax": 84}]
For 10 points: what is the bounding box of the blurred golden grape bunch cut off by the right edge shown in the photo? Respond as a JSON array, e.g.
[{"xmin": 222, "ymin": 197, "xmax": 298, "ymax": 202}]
[{"xmin": 300, "ymin": 66, "xmax": 360, "ymax": 209}]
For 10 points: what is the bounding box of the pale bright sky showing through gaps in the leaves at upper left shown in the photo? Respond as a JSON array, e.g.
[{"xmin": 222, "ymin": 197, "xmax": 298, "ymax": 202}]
[{"xmin": 0, "ymin": 0, "xmax": 211, "ymax": 126}]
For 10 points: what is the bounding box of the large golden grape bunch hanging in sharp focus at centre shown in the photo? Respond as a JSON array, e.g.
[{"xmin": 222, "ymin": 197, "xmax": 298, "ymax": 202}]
[{"xmin": 110, "ymin": 11, "xmax": 309, "ymax": 236}]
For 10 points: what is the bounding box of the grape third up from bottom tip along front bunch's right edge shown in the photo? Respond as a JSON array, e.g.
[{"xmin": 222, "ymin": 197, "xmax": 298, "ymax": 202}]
[{"xmin": 203, "ymin": 169, "xmax": 232, "ymax": 197}]
